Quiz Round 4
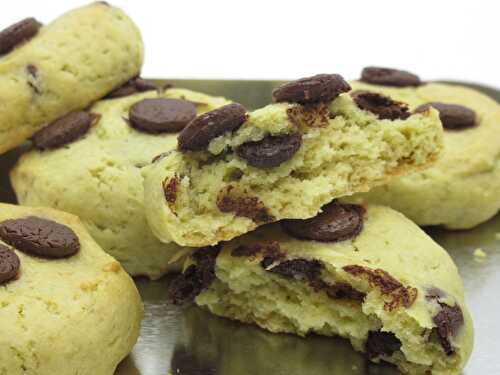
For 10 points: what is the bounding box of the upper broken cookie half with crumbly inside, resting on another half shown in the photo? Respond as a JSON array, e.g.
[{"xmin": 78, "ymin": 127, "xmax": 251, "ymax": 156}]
[{"xmin": 144, "ymin": 75, "xmax": 442, "ymax": 247}]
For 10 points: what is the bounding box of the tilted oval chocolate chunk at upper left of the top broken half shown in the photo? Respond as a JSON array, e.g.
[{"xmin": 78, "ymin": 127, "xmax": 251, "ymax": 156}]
[{"xmin": 178, "ymin": 103, "xmax": 248, "ymax": 151}]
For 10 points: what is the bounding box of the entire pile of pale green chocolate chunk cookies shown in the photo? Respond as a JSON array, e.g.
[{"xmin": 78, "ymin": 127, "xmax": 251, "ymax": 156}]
[{"xmin": 0, "ymin": 2, "xmax": 500, "ymax": 375}]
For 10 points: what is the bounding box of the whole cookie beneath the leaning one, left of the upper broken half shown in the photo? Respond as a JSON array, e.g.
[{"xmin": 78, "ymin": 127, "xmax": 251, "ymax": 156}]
[{"xmin": 11, "ymin": 89, "xmax": 228, "ymax": 279}]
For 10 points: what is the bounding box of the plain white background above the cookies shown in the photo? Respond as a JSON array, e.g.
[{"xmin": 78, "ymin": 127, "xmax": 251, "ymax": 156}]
[{"xmin": 0, "ymin": 0, "xmax": 500, "ymax": 87}]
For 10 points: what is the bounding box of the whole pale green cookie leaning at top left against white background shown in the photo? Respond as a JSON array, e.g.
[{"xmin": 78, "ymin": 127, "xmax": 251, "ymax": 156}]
[{"xmin": 0, "ymin": 2, "xmax": 143, "ymax": 153}]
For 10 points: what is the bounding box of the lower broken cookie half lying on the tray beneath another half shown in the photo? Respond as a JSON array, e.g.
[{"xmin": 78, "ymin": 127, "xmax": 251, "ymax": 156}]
[{"xmin": 170, "ymin": 206, "xmax": 473, "ymax": 375}]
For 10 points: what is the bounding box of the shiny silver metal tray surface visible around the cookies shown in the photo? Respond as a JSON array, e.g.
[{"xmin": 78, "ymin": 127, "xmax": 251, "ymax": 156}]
[{"xmin": 0, "ymin": 80, "xmax": 500, "ymax": 375}]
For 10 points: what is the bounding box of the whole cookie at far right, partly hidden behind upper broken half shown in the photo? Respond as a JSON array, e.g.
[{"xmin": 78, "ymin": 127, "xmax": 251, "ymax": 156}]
[{"xmin": 351, "ymin": 70, "xmax": 500, "ymax": 229}]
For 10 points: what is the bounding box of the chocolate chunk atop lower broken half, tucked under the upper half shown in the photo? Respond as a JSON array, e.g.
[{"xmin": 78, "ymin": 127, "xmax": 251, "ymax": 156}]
[{"xmin": 281, "ymin": 201, "xmax": 365, "ymax": 242}]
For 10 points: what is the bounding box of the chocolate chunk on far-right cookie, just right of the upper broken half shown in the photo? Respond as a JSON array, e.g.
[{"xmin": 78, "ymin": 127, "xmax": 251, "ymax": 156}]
[{"xmin": 415, "ymin": 102, "xmax": 476, "ymax": 130}]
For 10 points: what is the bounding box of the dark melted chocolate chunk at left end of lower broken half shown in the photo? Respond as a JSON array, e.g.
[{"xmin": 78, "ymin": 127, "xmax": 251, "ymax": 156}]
[{"xmin": 168, "ymin": 247, "xmax": 220, "ymax": 305}]
